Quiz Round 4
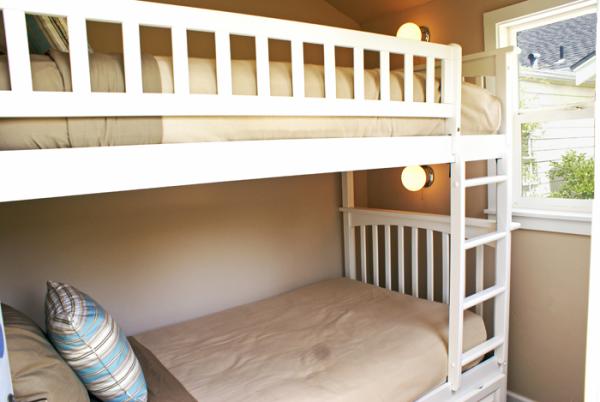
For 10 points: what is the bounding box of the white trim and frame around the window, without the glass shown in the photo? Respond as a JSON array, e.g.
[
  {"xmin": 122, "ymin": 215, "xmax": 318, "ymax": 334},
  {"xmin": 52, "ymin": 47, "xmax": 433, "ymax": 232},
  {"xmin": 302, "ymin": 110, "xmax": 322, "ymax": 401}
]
[{"xmin": 483, "ymin": 0, "xmax": 600, "ymax": 236}]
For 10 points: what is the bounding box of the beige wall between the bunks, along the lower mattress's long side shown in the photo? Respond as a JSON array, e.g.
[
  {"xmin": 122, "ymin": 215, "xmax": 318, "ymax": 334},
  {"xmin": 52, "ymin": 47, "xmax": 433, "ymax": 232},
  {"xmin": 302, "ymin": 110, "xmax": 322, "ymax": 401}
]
[{"xmin": 0, "ymin": 174, "xmax": 342, "ymax": 334}]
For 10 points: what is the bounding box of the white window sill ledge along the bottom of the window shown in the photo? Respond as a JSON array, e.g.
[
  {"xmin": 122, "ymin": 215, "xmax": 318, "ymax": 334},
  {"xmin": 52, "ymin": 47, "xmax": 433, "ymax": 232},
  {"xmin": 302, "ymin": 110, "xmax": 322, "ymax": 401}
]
[{"xmin": 484, "ymin": 208, "xmax": 592, "ymax": 236}]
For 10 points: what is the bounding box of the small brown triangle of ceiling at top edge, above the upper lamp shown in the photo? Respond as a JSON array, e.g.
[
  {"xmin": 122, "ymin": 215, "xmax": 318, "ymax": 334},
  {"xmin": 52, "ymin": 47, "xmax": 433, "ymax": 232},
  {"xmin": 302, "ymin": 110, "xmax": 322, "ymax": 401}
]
[{"xmin": 326, "ymin": 0, "xmax": 431, "ymax": 24}]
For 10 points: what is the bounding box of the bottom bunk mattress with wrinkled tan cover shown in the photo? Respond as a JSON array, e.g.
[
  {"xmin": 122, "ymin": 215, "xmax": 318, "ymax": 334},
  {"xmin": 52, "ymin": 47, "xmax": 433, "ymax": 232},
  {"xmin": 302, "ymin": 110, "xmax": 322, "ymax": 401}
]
[{"xmin": 132, "ymin": 278, "xmax": 486, "ymax": 402}]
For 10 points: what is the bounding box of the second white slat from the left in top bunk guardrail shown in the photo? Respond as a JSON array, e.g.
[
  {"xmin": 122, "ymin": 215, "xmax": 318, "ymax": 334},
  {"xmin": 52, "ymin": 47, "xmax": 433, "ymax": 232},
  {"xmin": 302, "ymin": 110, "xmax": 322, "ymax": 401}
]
[{"xmin": 67, "ymin": 16, "xmax": 90, "ymax": 94}]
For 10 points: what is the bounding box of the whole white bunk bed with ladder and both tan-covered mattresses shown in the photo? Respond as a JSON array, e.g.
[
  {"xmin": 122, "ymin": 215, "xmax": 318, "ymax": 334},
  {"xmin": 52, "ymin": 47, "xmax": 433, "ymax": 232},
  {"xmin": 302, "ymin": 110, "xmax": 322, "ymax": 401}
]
[{"xmin": 0, "ymin": 0, "xmax": 516, "ymax": 401}]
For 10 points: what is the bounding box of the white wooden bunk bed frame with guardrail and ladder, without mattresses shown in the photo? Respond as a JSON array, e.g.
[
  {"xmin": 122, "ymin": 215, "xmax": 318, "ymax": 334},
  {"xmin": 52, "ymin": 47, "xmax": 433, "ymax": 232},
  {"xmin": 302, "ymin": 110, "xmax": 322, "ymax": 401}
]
[{"xmin": 0, "ymin": 0, "xmax": 516, "ymax": 401}]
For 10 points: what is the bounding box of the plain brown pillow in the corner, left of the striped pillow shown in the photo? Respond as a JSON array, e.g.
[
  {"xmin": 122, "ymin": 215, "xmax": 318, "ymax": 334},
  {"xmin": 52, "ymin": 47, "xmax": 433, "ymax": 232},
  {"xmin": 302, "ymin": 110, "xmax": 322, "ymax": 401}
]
[{"xmin": 2, "ymin": 304, "xmax": 89, "ymax": 402}]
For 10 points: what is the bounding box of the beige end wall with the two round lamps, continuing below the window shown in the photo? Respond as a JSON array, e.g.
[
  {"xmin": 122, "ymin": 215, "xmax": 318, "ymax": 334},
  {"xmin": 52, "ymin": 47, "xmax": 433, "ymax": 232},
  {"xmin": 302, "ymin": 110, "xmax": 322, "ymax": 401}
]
[{"xmin": 362, "ymin": 0, "xmax": 590, "ymax": 402}]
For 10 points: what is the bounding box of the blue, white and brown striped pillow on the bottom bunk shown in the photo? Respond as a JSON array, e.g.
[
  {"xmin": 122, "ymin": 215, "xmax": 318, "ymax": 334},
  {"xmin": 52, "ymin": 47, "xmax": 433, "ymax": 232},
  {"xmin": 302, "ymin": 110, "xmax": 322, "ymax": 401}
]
[{"xmin": 46, "ymin": 282, "xmax": 148, "ymax": 402}]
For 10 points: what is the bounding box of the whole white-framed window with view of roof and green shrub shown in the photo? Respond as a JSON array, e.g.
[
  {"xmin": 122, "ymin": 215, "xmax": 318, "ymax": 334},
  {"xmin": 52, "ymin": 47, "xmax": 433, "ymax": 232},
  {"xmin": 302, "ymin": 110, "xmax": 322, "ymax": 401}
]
[{"xmin": 484, "ymin": 0, "xmax": 597, "ymax": 234}]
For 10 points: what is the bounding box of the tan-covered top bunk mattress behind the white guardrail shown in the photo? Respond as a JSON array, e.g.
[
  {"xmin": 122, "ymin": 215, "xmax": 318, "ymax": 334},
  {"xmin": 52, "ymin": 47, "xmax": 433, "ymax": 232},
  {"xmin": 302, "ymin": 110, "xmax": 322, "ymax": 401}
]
[{"xmin": 0, "ymin": 51, "xmax": 501, "ymax": 150}]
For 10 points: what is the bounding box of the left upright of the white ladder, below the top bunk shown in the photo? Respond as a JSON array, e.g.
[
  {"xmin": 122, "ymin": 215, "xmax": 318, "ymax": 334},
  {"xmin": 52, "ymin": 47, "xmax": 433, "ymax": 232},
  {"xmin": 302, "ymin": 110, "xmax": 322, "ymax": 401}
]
[{"xmin": 448, "ymin": 159, "xmax": 466, "ymax": 391}]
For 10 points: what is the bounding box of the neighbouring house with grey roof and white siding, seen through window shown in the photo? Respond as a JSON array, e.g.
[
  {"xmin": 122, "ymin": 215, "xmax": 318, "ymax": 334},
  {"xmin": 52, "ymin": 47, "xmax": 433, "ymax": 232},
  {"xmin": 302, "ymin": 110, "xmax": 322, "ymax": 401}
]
[{"xmin": 517, "ymin": 13, "xmax": 596, "ymax": 197}]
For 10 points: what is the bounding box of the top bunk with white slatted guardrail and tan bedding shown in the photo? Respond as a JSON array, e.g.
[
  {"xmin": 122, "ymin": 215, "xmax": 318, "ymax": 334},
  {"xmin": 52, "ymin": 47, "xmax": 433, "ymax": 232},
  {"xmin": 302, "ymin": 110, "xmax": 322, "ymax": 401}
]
[{"xmin": 0, "ymin": 0, "xmax": 514, "ymax": 201}]
